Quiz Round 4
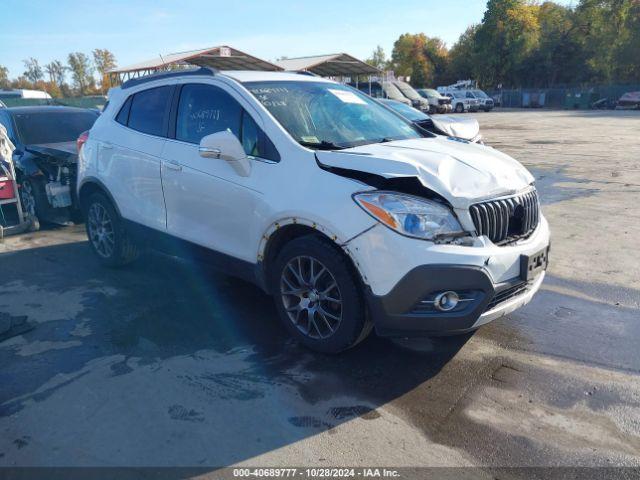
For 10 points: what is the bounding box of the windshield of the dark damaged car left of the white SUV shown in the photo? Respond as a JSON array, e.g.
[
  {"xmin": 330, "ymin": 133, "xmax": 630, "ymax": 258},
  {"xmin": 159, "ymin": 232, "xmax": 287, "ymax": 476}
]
[{"xmin": 14, "ymin": 111, "xmax": 98, "ymax": 145}]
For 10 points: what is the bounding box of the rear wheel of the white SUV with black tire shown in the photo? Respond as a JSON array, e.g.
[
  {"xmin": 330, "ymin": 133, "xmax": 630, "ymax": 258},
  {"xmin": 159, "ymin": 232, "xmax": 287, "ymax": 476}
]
[{"xmin": 84, "ymin": 193, "xmax": 138, "ymax": 267}]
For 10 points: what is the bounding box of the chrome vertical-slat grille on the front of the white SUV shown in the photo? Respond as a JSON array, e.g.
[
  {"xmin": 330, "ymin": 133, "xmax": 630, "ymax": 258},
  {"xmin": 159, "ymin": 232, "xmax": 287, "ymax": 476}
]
[{"xmin": 469, "ymin": 189, "xmax": 540, "ymax": 245}]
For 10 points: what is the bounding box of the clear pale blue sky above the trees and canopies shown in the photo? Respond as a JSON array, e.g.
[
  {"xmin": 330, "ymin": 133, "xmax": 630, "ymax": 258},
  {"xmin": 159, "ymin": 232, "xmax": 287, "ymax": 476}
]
[{"xmin": 0, "ymin": 0, "xmax": 576, "ymax": 78}]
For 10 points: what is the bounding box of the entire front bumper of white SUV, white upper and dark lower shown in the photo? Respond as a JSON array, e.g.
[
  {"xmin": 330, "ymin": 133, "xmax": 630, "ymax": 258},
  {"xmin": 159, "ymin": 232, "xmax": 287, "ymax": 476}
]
[{"xmin": 348, "ymin": 216, "xmax": 549, "ymax": 337}]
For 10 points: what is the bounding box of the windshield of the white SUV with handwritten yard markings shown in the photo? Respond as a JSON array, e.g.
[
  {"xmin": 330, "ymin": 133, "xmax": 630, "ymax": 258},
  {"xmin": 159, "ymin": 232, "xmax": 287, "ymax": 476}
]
[{"xmin": 245, "ymin": 81, "xmax": 421, "ymax": 149}]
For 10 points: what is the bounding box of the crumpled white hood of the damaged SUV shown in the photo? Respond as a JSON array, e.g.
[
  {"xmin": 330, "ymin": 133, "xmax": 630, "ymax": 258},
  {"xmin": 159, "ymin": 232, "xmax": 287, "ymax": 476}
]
[{"xmin": 316, "ymin": 137, "xmax": 534, "ymax": 208}]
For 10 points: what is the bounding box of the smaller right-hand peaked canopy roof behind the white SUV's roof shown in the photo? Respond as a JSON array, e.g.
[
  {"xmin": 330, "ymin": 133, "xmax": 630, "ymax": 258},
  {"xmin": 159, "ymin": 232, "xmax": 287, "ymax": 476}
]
[{"xmin": 276, "ymin": 53, "xmax": 382, "ymax": 77}]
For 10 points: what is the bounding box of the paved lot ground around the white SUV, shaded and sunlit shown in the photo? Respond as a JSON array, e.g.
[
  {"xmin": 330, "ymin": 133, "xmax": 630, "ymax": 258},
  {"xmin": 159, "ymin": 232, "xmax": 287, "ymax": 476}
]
[{"xmin": 0, "ymin": 111, "xmax": 640, "ymax": 478}]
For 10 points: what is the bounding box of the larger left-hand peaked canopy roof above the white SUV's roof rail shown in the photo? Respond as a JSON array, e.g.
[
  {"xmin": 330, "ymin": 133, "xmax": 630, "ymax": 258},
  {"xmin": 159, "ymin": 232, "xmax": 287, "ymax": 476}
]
[{"xmin": 108, "ymin": 46, "xmax": 283, "ymax": 85}]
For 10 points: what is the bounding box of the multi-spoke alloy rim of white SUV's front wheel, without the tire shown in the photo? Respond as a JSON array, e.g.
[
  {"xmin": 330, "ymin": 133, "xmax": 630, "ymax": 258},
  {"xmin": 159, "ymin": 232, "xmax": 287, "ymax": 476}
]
[{"xmin": 280, "ymin": 256, "xmax": 342, "ymax": 339}]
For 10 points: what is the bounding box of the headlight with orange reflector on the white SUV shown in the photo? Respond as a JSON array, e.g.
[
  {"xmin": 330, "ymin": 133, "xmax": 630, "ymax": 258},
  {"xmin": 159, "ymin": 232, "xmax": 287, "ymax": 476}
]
[{"xmin": 353, "ymin": 192, "xmax": 465, "ymax": 240}]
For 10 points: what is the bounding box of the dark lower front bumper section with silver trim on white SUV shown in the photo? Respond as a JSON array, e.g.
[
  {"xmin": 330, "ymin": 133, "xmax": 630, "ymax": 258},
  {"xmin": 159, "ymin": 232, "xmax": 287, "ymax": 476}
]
[{"xmin": 367, "ymin": 265, "xmax": 545, "ymax": 337}]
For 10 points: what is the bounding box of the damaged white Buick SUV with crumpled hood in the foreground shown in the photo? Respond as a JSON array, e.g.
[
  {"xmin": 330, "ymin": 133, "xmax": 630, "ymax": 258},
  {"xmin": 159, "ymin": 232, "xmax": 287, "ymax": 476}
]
[{"xmin": 78, "ymin": 69, "xmax": 549, "ymax": 352}]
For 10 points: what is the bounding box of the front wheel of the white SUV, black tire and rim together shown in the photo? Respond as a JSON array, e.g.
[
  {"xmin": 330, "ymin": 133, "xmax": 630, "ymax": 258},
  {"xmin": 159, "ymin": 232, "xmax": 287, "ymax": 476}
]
[{"xmin": 271, "ymin": 235, "xmax": 373, "ymax": 353}]
